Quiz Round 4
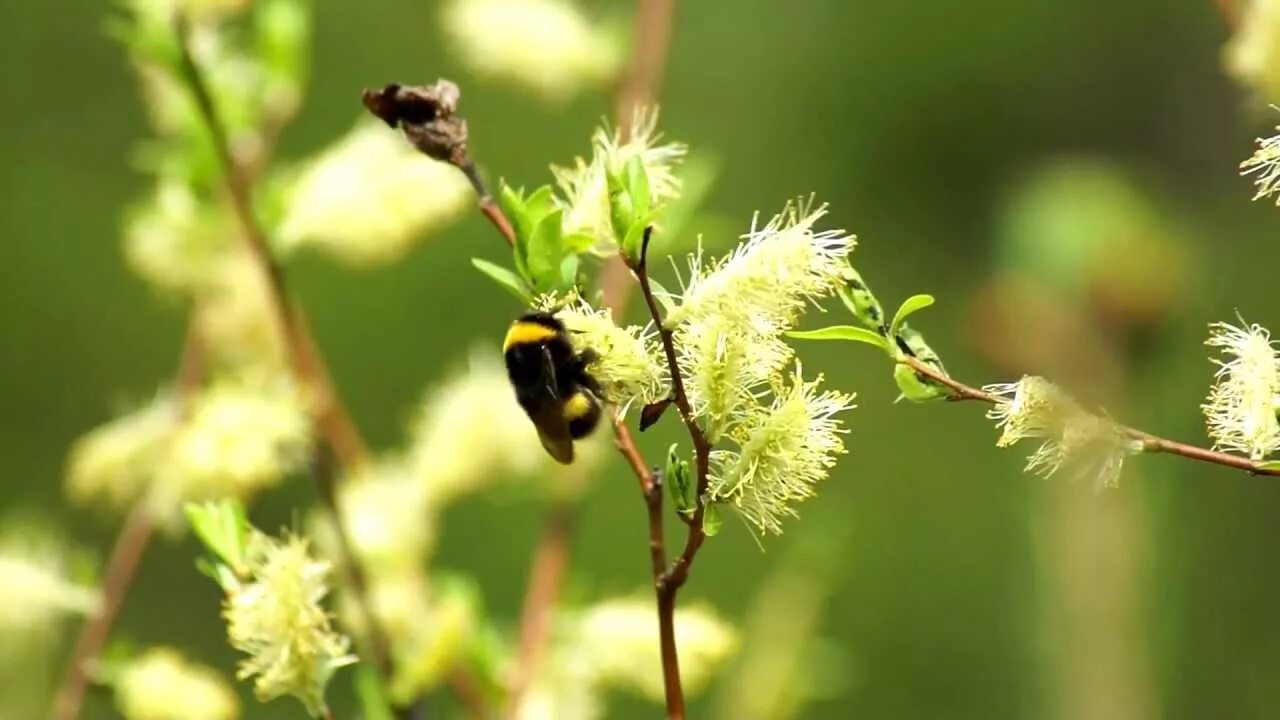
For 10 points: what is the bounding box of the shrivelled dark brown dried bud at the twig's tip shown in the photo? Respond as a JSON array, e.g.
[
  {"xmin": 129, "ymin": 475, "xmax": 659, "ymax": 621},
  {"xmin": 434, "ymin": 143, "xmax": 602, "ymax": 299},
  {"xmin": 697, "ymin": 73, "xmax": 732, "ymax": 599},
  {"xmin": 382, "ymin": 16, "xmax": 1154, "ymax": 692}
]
[{"xmin": 361, "ymin": 79, "xmax": 470, "ymax": 168}]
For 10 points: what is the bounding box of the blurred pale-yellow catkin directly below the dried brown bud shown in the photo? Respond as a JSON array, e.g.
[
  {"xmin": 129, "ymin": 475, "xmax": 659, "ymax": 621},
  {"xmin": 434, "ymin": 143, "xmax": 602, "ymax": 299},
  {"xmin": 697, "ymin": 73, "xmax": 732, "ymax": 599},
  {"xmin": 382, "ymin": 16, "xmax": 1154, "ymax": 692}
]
[{"xmin": 278, "ymin": 120, "xmax": 474, "ymax": 265}]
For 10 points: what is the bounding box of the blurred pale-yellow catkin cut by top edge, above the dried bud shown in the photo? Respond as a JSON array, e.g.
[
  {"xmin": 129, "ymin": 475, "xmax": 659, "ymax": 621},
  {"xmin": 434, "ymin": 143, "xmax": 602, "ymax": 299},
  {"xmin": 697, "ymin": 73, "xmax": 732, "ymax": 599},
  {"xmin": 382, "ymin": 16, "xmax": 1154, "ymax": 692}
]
[{"xmin": 442, "ymin": 0, "xmax": 621, "ymax": 102}]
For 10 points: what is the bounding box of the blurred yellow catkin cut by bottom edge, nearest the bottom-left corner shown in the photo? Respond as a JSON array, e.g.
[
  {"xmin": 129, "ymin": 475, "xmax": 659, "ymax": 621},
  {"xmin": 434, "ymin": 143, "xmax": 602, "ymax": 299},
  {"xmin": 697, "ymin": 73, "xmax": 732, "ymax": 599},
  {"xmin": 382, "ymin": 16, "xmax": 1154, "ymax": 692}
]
[{"xmin": 113, "ymin": 647, "xmax": 239, "ymax": 720}]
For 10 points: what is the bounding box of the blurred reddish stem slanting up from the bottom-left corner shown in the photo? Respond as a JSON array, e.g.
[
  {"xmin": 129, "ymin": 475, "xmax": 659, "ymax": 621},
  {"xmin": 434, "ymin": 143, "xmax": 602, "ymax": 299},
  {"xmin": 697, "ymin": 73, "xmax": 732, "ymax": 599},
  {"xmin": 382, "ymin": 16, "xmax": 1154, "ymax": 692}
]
[{"xmin": 52, "ymin": 319, "xmax": 205, "ymax": 720}]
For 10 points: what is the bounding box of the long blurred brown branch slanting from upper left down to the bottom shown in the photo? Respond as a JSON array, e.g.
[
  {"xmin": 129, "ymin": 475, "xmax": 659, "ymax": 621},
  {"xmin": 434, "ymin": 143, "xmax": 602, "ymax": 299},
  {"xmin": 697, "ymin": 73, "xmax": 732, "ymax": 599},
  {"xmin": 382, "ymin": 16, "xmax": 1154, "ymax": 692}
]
[{"xmin": 174, "ymin": 15, "xmax": 410, "ymax": 717}]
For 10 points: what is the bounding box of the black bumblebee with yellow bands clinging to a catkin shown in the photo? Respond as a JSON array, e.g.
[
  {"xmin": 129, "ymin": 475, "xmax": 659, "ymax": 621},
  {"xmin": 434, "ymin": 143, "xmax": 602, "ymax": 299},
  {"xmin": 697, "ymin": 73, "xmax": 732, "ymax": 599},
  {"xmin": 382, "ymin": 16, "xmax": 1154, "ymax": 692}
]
[{"xmin": 502, "ymin": 313, "xmax": 602, "ymax": 465}]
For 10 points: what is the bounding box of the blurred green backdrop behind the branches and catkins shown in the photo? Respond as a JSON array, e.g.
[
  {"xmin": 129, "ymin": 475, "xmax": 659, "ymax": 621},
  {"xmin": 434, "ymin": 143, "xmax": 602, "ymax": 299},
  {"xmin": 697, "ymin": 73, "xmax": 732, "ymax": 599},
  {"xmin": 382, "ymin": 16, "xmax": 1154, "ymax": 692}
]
[{"xmin": 0, "ymin": 0, "xmax": 1280, "ymax": 719}]
